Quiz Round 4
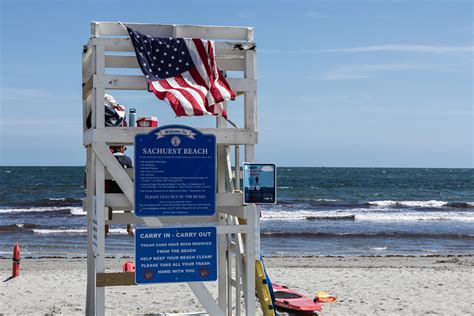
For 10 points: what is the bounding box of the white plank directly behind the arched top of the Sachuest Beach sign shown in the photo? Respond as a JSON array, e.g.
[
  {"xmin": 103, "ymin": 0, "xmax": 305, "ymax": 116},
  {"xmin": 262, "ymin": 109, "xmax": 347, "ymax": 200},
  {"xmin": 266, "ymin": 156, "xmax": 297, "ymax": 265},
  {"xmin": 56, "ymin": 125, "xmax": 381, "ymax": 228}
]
[{"xmin": 83, "ymin": 127, "xmax": 258, "ymax": 146}]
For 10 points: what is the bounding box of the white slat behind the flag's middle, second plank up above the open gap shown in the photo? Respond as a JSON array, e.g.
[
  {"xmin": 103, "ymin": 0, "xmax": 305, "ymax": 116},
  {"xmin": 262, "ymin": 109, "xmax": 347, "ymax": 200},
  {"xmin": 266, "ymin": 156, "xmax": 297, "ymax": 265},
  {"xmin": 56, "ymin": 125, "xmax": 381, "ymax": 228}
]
[{"xmin": 103, "ymin": 55, "xmax": 245, "ymax": 71}]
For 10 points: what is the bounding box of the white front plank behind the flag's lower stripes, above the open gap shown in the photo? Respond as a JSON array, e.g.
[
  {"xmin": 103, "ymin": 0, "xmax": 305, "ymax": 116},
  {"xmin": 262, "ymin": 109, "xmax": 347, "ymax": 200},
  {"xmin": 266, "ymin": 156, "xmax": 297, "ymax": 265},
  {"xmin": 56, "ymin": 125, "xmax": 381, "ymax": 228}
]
[{"xmin": 93, "ymin": 75, "xmax": 257, "ymax": 92}]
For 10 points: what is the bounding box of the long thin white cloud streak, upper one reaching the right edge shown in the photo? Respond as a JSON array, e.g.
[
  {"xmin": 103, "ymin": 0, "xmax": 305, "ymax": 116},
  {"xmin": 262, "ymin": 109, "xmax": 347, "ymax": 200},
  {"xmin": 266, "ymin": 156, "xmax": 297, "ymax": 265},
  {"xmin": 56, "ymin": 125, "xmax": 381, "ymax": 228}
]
[{"xmin": 320, "ymin": 44, "xmax": 474, "ymax": 54}]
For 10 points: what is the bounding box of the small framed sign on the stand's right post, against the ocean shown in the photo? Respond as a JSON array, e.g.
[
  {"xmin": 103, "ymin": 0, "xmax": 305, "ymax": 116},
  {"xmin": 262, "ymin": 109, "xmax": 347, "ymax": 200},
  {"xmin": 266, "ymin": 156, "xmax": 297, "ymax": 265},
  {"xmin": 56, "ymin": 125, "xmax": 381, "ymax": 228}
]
[{"xmin": 243, "ymin": 163, "xmax": 276, "ymax": 204}]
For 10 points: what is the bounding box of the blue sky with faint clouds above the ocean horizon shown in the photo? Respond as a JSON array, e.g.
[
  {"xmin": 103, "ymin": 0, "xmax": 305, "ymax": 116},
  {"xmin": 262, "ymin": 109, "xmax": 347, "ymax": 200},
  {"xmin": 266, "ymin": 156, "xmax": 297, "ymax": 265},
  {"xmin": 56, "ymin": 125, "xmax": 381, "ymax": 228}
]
[{"xmin": 0, "ymin": 0, "xmax": 474, "ymax": 168}]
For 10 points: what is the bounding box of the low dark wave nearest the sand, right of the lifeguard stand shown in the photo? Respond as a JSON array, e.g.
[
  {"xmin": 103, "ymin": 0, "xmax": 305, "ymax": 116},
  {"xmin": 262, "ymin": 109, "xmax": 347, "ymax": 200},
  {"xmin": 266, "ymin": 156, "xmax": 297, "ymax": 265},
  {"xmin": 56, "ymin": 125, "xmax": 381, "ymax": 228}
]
[{"xmin": 260, "ymin": 231, "xmax": 474, "ymax": 240}]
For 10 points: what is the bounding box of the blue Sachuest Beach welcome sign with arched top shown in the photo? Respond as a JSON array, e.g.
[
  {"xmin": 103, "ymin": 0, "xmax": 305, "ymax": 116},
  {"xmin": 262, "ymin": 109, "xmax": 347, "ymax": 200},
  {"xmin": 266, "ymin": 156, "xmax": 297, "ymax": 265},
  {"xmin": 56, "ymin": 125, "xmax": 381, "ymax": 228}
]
[{"xmin": 135, "ymin": 125, "xmax": 216, "ymax": 216}]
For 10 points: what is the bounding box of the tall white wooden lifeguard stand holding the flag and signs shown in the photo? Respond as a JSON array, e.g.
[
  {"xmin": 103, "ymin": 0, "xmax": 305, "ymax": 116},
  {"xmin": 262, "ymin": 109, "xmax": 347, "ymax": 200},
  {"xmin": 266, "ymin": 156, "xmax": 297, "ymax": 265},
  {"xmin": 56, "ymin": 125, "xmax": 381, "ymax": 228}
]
[{"xmin": 82, "ymin": 22, "xmax": 260, "ymax": 315}]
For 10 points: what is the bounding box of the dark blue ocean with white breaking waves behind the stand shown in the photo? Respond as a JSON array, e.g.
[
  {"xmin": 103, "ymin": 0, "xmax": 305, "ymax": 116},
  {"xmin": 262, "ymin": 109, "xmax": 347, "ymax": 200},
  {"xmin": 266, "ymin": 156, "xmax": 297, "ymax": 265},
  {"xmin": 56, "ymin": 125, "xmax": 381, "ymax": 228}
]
[{"xmin": 0, "ymin": 167, "xmax": 474, "ymax": 258}]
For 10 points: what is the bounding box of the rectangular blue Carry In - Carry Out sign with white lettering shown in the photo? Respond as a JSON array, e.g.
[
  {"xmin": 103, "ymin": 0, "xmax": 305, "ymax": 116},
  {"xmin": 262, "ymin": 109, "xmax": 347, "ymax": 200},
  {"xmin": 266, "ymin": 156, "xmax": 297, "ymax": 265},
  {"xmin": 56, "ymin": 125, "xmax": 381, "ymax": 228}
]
[{"xmin": 135, "ymin": 227, "xmax": 217, "ymax": 284}]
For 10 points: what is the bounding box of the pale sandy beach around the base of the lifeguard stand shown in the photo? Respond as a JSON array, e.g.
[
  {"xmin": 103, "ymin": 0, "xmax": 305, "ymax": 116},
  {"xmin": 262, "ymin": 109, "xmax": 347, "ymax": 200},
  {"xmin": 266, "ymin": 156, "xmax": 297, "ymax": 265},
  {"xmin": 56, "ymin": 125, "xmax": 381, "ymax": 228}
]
[{"xmin": 0, "ymin": 256, "xmax": 474, "ymax": 315}]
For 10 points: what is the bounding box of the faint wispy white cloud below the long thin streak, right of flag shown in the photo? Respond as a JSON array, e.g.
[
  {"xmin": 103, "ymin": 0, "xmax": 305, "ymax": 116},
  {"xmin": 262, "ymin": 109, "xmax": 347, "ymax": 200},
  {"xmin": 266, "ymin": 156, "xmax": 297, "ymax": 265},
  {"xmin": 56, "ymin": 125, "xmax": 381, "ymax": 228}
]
[{"xmin": 323, "ymin": 64, "xmax": 434, "ymax": 80}]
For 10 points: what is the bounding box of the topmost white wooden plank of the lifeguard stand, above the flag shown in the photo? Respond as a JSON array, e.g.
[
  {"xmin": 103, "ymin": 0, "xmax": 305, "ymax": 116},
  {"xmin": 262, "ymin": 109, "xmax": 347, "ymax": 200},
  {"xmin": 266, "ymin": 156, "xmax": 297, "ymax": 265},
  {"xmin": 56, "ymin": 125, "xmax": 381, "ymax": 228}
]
[{"xmin": 91, "ymin": 21, "xmax": 253, "ymax": 40}]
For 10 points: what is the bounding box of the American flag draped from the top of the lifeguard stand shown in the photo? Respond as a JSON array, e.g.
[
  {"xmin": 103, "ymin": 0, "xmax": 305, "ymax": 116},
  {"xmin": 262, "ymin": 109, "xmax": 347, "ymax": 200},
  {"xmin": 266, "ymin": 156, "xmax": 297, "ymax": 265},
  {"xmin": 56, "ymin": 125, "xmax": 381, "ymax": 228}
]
[{"xmin": 127, "ymin": 27, "xmax": 235, "ymax": 118}]
